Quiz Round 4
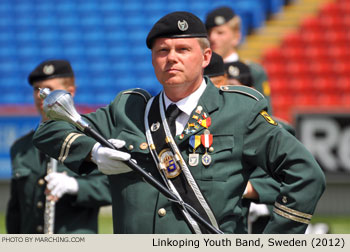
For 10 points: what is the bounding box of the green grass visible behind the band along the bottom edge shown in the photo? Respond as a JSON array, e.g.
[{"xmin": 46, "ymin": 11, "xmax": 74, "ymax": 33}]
[{"xmin": 0, "ymin": 213, "xmax": 350, "ymax": 234}]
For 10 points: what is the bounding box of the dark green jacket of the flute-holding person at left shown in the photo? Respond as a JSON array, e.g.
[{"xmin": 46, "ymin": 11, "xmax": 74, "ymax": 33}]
[{"xmin": 6, "ymin": 131, "xmax": 111, "ymax": 234}]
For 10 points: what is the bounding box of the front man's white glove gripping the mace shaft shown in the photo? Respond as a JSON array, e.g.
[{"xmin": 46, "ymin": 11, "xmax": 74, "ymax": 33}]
[{"xmin": 91, "ymin": 139, "xmax": 132, "ymax": 175}]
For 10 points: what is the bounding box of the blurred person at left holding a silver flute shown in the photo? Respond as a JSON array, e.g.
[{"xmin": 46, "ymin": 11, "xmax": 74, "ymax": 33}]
[{"xmin": 6, "ymin": 60, "xmax": 111, "ymax": 234}]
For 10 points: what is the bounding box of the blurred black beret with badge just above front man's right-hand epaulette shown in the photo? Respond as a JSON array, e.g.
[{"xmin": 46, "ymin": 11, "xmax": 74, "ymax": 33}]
[{"xmin": 225, "ymin": 61, "xmax": 253, "ymax": 87}]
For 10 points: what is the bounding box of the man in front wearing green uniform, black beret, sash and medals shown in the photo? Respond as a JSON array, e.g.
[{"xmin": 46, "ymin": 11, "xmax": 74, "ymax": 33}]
[{"xmin": 34, "ymin": 12, "xmax": 325, "ymax": 233}]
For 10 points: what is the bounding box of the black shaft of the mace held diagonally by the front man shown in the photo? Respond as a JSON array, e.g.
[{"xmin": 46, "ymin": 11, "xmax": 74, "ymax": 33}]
[{"xmin": 84, "ymin": 126, "xmax": 223, "ymax": 234}]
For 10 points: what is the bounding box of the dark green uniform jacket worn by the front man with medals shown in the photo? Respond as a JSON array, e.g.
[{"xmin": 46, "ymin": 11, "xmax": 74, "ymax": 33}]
[{"xmin": 34, "ymin": 78, "xmax": 325, "ymax": 233}]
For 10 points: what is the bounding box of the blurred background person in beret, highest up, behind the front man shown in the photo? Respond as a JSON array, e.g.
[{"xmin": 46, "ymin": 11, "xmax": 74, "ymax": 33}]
[{"xmin": 205, "ymin": 6, "xmax": 271, "ymax": 110}]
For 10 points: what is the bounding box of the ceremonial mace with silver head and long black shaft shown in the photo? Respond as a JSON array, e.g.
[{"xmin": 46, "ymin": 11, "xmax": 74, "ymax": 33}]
[{"xmin": 40, "ymin": 88, "xmax": 223, "ymax": 234}]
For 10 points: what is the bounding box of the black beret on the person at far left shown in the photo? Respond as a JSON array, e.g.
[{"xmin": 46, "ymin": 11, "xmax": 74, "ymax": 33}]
[{"xmin": 28, "ymin": 60, "xmax": 74, "ymax": 85}]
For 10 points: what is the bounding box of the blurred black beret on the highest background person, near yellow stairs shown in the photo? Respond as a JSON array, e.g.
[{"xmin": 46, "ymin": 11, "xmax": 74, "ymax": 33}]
[{"xmin": 205, "ymin": 6, "xmax": 236, "ymax": 30}]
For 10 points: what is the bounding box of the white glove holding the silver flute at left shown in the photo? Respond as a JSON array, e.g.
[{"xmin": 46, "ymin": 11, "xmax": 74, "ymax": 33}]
[{"xmin": 45, "ymin": 172, "xmax": 79, "ymax": 198}]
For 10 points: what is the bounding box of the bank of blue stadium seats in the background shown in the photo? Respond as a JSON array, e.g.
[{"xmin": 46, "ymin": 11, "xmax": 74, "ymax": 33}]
[{"xmin": 0, "ymin": 0, "xmax": 270, "ymax": 105}]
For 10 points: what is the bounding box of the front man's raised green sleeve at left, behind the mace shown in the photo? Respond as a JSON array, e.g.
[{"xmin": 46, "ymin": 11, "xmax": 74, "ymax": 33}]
[{"xmin": 33, "ymin": 89, "xmax": 148, "ymax": 174}]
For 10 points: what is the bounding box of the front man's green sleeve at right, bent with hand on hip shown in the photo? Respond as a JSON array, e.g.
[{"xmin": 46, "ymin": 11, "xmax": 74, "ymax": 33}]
[{"xmin": 243, "ymin": 102, "xmax": 325, "ymax": 233}]
